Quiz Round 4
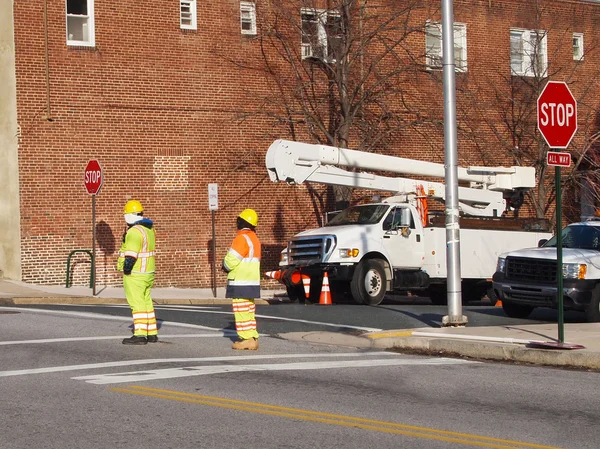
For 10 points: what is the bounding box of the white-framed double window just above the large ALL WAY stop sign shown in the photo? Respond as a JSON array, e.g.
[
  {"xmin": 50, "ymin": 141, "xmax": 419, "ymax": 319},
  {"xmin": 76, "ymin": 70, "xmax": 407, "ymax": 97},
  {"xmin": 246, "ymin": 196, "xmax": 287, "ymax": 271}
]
[{"xmin": 510, "ymin": 29, "xmax": 548, "ymax": 77}]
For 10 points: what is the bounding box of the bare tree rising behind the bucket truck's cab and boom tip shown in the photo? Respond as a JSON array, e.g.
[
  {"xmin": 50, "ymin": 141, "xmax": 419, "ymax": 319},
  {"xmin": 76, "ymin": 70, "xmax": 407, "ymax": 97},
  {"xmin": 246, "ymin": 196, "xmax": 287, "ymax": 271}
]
[{"xmin": 227, "ymin": 0, "xmax": 438, "ymax": 207}]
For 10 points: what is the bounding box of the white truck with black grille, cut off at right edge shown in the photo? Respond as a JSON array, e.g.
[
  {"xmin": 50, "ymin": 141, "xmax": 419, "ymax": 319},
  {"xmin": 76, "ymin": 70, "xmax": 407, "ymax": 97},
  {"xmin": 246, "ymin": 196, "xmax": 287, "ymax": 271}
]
[{"xmin": 493, "ymin": 219, "xmax": 600, "ymax": 323}]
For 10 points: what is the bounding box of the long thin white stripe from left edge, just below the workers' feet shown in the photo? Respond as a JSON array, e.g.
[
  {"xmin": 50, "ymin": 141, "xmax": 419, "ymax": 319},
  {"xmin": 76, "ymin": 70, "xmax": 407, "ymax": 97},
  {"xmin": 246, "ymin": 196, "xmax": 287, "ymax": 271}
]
[{"xmin": 0, "ymin": 352, "xmax": 398, "ymax": 377}]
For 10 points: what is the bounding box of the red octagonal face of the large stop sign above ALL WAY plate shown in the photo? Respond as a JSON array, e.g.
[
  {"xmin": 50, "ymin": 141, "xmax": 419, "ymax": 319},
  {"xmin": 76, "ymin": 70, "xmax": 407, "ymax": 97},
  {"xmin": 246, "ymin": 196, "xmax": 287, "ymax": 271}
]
[{"xmin": 537, "ymin": 81, "xmax": 577, "ymax": 148}]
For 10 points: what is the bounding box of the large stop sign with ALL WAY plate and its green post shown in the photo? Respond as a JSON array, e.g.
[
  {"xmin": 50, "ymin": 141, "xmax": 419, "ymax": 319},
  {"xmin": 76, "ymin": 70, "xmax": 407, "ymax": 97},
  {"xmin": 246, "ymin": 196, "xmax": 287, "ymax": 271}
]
[{"xmin": 537, "ymin": 81, "xmax": 577, "ymax": 345}]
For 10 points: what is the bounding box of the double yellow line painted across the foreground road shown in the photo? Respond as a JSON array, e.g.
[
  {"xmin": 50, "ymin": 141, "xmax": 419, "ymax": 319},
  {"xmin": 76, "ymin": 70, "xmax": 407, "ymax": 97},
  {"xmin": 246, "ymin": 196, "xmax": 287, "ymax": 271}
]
[{"xmin": 110, "ymin": 385, "xmax": 560, "ymax": 449}]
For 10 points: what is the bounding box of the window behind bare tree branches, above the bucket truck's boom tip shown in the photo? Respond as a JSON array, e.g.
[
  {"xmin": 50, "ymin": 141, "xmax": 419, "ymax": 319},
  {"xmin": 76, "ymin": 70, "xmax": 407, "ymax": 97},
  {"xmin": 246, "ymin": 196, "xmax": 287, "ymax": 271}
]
[{"xmin": 300, "ymin": 8, "xmax": 342, "ymax": 62}]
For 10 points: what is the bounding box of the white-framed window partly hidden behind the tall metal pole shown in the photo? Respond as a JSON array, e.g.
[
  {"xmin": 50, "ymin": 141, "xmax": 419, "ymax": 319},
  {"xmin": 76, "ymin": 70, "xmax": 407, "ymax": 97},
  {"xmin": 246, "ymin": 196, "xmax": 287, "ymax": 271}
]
[{"xmin": 425, "ymin": 22, "xmax": 467, "ymax": 72}]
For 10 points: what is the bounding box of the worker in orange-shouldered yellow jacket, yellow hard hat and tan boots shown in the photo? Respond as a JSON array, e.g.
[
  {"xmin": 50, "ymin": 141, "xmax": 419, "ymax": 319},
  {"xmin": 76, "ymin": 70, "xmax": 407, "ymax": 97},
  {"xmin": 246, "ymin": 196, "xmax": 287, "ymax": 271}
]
[{"xmin": 223, "ymin": 209, "xmax": 261, "ymax": 350}]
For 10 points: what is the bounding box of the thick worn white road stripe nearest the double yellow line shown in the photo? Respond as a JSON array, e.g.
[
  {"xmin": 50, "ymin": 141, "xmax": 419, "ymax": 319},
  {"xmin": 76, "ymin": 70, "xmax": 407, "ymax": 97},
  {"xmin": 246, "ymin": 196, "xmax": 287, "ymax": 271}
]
[{"xmin": 72, "ymin": 358, "xmax": 476, "ymax": 385}]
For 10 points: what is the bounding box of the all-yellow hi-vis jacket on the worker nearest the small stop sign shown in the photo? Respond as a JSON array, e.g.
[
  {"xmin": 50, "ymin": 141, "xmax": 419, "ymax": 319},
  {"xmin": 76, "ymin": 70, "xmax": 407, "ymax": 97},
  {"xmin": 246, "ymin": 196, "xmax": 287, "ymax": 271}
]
[{"xmin": 117, "ymin": 219, "xmax": 156, "ymax": 274}]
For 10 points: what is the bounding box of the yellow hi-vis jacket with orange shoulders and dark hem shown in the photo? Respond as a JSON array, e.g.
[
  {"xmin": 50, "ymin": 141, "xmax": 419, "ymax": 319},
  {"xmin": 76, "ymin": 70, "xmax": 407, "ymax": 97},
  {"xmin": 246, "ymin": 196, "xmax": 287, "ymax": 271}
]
[{"xmin": 223, "ymin": 229, "xmax": 261, "ymax": 299}]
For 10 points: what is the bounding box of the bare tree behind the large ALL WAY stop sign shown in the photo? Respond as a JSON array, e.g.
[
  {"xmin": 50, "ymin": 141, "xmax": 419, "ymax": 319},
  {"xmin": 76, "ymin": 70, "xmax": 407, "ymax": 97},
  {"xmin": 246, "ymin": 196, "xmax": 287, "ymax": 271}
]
[{"xmin": 452, "ymin": 1, "xmax": 600, "ymax": 224}]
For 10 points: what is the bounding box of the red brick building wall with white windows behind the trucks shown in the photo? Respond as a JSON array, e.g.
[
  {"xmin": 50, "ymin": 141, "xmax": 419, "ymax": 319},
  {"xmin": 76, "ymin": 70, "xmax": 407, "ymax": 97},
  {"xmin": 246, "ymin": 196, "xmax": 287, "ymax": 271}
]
[{"xmin": 0, "ymin": 0, "xmax": 600, "ymax": 287}]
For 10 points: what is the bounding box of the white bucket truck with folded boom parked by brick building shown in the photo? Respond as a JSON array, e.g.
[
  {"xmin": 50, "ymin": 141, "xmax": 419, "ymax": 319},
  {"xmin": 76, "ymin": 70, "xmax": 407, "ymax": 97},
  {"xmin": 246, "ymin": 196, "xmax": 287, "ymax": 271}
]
[{"xmin": 266, "ymin": 140, "xmax": 551, "ymax": 305}]
